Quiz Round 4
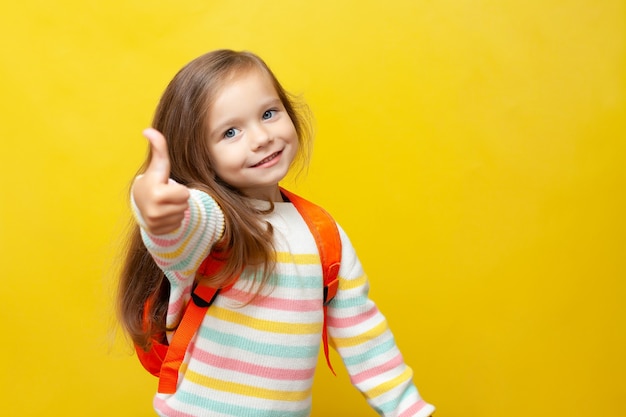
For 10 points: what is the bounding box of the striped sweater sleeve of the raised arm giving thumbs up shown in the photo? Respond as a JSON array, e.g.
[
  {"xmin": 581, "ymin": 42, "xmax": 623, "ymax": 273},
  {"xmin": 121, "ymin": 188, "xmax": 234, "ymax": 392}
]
[{"xmin": 131, "ymin": 189, "xmax": 224, "ymax": 327}]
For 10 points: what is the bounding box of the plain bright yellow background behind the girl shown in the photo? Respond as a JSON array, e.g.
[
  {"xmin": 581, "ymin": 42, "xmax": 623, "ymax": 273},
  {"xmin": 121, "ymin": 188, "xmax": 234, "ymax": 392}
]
[{"xmin": 0, "ymin": 0, "xmax": 626, "ymax": 417}]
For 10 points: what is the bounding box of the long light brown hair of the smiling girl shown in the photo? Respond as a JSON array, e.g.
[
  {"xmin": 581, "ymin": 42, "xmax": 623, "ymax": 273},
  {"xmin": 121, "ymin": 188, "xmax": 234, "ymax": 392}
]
[{"xmin": 117, "ymin": 50, "xmax": 312, "ymax": 350}]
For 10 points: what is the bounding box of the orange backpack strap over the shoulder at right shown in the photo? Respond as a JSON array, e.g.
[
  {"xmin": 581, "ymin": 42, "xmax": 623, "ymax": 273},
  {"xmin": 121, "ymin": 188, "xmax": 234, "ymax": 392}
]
[{"xmin": 280, "ymin": 188, "xmax": 341, "ymax": 375}]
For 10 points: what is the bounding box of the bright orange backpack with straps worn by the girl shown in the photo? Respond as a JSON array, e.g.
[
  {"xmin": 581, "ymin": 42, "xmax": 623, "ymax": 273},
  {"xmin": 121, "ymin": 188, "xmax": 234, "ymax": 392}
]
[{"xmin": 135, "ymin": 188, "xmax": 341, "ymax": 394}]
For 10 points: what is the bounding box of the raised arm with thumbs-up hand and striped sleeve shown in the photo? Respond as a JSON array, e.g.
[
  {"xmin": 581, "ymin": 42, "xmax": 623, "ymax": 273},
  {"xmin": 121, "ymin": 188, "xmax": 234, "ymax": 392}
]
[{"xmin": 131, "ymin": 129, "xmax": 224, "ymax": 327}]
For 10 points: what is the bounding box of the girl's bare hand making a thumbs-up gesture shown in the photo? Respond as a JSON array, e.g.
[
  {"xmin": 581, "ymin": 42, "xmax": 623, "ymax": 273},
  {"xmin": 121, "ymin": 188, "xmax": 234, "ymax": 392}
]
[{"xmin": 132, "ymin": 128, "xmax": 189, "ymax": 235}]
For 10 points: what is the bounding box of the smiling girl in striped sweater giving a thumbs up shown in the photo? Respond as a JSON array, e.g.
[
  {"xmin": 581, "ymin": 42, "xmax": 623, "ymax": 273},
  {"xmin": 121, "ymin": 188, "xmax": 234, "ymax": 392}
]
[{"xmin": 118, "ymin": 50, "xmax": 434, "ymax": 417}]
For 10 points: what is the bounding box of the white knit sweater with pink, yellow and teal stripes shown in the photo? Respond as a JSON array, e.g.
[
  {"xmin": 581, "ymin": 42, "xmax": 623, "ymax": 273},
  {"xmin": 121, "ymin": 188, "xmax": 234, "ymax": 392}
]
[{"xmin": 133, "ymin": 190, "xmax": 434, "ymax": 417}]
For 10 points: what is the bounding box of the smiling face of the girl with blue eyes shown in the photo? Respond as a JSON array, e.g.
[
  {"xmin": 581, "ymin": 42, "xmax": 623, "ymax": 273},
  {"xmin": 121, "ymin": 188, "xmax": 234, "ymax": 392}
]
[{"xmin": 207, "ymin": 70, "xmax": 298, "ymax": 201}]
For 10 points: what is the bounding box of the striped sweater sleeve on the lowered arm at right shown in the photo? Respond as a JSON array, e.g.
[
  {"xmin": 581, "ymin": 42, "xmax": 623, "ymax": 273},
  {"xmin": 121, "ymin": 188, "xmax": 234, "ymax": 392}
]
[{"xmin": 328, "ymin": 229, "xmax": 435, "ymax": 417}]
